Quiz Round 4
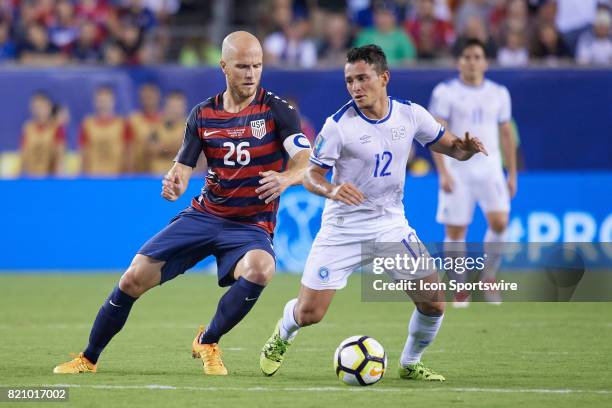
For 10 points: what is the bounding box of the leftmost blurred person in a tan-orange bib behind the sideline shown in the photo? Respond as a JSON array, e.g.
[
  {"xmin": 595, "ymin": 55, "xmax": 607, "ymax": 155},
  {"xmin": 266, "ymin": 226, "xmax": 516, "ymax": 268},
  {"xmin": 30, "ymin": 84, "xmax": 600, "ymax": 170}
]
[{"xmin": 20, "ymin": 92, "xmax": 66, "ymax": 177}]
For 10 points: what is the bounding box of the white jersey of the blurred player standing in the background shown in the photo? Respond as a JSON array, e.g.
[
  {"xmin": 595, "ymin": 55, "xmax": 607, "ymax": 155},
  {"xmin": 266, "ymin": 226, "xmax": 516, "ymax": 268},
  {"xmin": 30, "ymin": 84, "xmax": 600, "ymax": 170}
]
[{"xmin": 429, "ymin": 78, "xmax": 512, "ymax": 176}]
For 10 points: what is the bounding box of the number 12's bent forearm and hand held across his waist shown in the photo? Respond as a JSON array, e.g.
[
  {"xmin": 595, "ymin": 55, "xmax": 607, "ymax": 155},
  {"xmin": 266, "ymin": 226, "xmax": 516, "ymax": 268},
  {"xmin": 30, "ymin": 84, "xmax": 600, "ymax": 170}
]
[{"xmin": 304, "ymin": 164, "xmax": 365, "ymax": 205}]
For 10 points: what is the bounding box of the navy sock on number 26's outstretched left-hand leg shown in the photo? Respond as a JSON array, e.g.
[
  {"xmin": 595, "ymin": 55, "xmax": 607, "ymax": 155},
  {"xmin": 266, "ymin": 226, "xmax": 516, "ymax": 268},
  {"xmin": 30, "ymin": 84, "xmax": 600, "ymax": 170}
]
[{"xmin": 83, "ymin": 286, "xmax": 138, "ymax": 364}]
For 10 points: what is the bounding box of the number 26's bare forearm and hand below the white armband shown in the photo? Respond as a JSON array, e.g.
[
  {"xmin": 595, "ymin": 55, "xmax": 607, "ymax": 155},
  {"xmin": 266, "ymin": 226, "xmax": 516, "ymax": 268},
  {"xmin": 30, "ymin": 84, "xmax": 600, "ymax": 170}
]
[{"xmin": 255, "ymin": 149, "xmax": 310, "ymax": 204}]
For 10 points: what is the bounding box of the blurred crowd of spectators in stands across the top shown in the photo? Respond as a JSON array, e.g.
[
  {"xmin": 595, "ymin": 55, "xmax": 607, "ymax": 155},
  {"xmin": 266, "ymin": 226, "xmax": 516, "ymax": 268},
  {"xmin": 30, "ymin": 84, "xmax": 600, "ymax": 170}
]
[{"xmin": 0, "ymin": 0, "xmax": 612, "ymax": 68}]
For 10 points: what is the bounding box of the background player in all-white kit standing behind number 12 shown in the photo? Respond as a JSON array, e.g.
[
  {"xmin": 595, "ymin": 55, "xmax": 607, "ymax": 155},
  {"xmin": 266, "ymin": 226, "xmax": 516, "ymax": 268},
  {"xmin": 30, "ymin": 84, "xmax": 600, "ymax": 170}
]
[{"xmin": 429, "ymin": 39, "xmax": 517, "ymax": 307}]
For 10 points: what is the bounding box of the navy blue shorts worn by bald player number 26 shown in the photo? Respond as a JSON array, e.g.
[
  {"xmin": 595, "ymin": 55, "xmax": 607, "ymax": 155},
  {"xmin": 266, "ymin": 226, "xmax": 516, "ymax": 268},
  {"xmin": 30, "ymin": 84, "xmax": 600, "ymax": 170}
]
[{"xmin": 138, "ymin": 207, "xmax": 276, "ymax": 286}]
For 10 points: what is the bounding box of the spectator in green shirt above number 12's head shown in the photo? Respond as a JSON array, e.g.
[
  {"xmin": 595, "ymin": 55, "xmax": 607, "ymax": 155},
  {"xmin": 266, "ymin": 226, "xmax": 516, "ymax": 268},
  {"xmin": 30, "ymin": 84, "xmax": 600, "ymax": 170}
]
[{"xmin": 355, "ymin": 0, "xmax": 416, "ymax": 66}]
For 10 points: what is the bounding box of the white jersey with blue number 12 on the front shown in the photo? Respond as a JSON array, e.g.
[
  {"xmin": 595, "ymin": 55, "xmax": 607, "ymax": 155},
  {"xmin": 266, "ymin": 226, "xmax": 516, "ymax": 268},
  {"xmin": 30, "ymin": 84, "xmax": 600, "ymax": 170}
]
[{"xmin": 310, "ymin": 98, "xmax": 444, "ymax": 241}]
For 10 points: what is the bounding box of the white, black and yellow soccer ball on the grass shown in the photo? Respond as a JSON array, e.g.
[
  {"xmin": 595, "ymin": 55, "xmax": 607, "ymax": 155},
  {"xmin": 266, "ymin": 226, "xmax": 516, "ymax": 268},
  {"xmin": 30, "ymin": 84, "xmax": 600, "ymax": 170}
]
[{"xmin": 334, "ymin": 336, "xmax": 387, "ymax": 385}]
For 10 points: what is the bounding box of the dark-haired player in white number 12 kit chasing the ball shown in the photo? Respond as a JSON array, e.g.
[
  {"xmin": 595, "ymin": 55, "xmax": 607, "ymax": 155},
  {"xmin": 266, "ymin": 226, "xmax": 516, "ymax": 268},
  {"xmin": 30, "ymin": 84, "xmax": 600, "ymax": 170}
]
[{"xmin": 260, "ymin": 45, "xmax": 486, "ymax": 381}]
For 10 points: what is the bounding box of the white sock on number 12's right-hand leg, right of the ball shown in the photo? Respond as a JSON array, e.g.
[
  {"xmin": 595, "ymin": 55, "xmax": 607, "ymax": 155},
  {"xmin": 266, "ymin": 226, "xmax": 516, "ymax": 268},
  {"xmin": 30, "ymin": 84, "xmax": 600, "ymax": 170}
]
[{"xmin": 400, "ymin": 308, "xmax": 444, "ymax": 366}]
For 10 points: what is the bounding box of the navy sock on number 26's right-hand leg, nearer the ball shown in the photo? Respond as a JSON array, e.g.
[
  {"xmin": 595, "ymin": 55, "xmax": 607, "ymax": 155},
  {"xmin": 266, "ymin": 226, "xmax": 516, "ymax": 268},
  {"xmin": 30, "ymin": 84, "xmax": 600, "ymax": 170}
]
[{"xmin": 200, "ymin": 276, "xmax": 264, "ymax": 344}]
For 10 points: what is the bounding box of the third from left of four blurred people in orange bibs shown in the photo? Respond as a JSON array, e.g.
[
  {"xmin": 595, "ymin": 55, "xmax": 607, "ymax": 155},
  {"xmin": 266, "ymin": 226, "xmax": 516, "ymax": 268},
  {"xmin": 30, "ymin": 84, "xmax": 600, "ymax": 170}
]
[{"xmin": 128, "ymin": 83, "xmax": 167, "ymax": 173}]
